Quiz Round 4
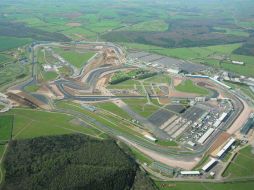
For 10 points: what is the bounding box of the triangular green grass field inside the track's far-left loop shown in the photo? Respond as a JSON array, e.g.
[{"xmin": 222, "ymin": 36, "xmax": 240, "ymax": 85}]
[{"xmin": 54, "ymin": 48, "xmax": 95, "ymax": 68}]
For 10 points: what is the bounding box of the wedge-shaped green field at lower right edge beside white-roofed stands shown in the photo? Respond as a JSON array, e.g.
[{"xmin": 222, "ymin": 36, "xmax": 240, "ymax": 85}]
[{"xmin": 223, "ymin": 146, "xmax": 254, "ymax": 178}]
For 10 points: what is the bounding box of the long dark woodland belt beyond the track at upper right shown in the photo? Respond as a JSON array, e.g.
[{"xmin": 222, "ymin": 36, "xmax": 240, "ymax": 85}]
[{"xmin": 102, "ymin": 18, "xmax": 248, "ymax": 48}]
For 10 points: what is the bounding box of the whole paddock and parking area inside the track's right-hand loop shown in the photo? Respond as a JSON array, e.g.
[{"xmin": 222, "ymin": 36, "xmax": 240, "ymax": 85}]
[{"xmin": 148, "ymin": 100, "xmax": 233, "ymax": 149}]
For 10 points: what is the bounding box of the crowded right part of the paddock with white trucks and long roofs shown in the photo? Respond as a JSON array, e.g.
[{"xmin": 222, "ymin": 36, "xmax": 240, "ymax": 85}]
[{"xmin": 179, "ymin": 100, "xmax": 232, "ymax": 148}]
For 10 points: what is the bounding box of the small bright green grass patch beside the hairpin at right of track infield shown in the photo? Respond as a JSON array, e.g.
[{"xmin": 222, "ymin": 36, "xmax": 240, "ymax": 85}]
[{"xmin": 175, "ymin": 80, "xmax": 208, "ymax": 95}]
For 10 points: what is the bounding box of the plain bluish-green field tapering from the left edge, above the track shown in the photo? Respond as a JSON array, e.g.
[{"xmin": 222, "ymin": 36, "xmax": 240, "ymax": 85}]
[{"xmin": 0, "ymin": 36, "xmax": 32, "ymax": 52}]
